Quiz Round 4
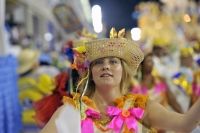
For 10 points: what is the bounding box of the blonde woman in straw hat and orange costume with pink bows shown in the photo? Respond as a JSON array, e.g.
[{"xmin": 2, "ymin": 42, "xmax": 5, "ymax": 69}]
[{"xmin": 35, "ymin": 30, "xmax": 200, "ymax": 133}]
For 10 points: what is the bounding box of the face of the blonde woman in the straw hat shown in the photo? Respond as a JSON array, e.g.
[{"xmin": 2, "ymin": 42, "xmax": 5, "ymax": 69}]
[{"xmin": 91, "ymin": 57, "xmax": 123, "ymax": 88}]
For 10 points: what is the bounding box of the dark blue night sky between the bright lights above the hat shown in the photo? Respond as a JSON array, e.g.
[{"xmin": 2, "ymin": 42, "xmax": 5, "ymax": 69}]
[{"xmin": 90, "ymin": 0, "xmax": 161, "ymax": 34}]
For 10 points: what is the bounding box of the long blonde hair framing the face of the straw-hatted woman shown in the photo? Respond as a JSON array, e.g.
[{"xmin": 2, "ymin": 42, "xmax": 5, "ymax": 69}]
[{"xmin": 78, "ymin": 59, "xmax": 134, "ymax": 98}]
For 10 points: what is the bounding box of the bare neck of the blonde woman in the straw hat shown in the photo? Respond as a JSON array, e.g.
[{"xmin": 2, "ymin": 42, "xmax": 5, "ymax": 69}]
[{"xmin": 93, "ymin": 88, "xmax": 122, "ymax": 112}]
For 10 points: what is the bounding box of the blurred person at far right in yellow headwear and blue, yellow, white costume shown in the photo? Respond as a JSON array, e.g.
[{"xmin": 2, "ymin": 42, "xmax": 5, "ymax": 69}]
[{"xmin": 172, "ymin": 47, "xmax": 194, "ymax": 112}]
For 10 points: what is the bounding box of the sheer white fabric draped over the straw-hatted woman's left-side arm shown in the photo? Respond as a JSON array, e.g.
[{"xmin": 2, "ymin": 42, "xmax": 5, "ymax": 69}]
[{"xmin": 55, "ymin": 105, "xmax": 81, "ymax": 133}]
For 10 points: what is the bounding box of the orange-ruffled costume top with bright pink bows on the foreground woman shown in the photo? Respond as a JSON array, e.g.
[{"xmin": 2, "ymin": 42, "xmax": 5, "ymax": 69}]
[{"xmin": 63, "ymin": 94, "xmax": 155, "ymax": 133}]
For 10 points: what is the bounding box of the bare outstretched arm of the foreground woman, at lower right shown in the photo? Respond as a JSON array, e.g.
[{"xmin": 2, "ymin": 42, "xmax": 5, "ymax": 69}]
[{"xmin": 144, "ymin": 98, "xmax": 200, "ymax": 133}]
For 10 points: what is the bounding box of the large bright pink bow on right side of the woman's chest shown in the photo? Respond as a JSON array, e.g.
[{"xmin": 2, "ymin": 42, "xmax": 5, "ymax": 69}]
[{"xmin": 107, "ymin": 106, "xmax": 144, "ymax": 133}]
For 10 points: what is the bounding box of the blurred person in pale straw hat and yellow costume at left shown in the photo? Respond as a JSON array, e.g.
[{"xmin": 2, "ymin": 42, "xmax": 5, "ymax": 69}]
[{"xmin": 17, "ymin": 48, "xmax": 58, "ymax": 129}]
